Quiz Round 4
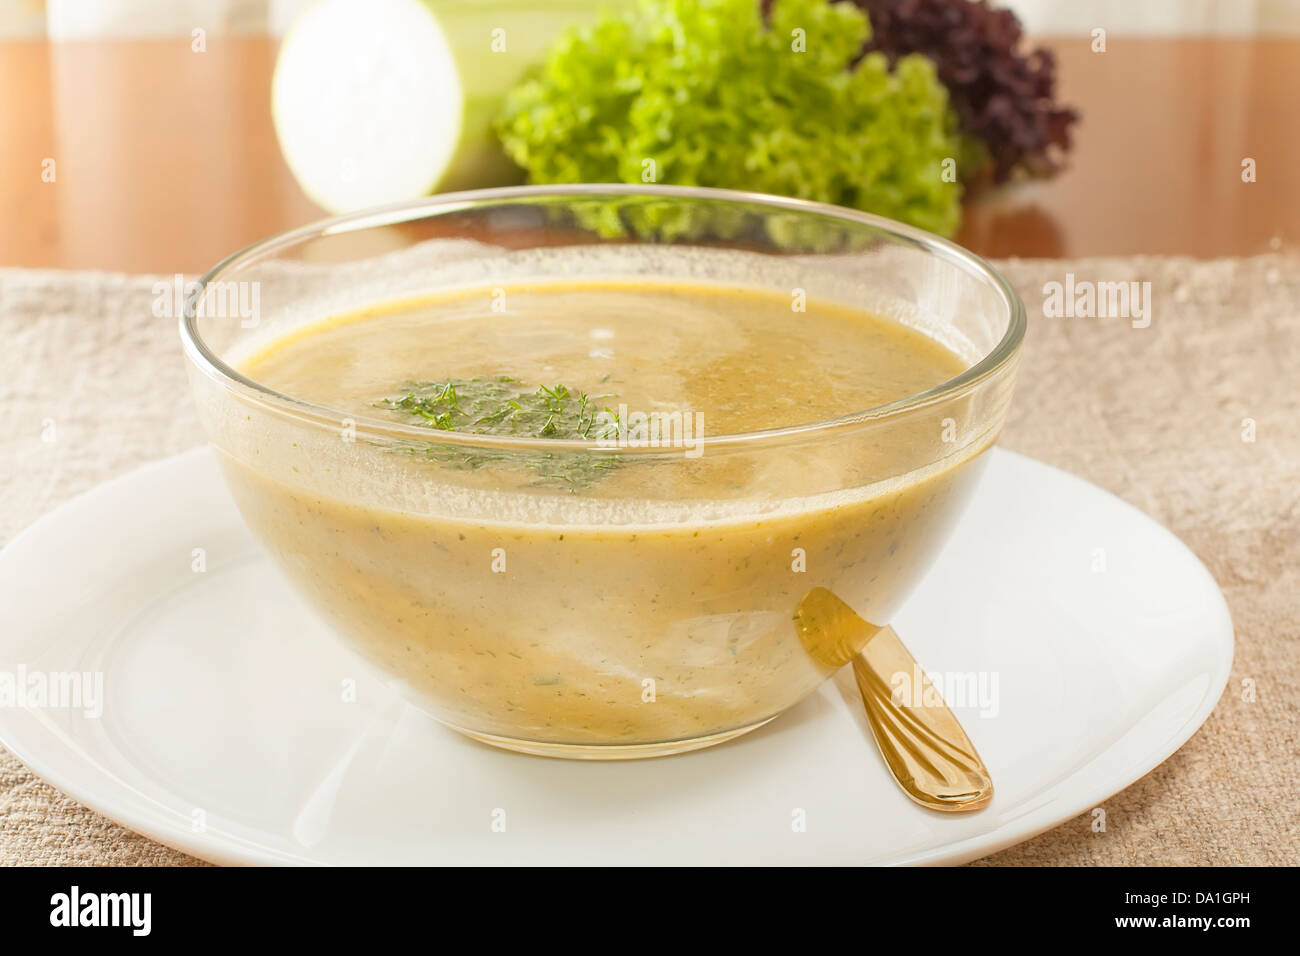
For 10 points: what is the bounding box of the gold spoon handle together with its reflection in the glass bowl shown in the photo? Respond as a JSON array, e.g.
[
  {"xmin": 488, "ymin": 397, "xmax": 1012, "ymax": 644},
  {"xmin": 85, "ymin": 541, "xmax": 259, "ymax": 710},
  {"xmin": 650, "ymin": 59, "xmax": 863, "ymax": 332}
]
[{"xmin": 794, "ymin": 588, "xmax": 993, "ymax": 813}]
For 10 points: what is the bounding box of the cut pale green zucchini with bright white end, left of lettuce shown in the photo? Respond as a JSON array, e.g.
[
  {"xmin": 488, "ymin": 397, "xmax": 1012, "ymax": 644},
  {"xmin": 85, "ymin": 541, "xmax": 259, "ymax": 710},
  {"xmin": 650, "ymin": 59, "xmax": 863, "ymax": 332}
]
[{"xmin": 272, "ymin": 0, "xmax": 619, "ymax": 212}]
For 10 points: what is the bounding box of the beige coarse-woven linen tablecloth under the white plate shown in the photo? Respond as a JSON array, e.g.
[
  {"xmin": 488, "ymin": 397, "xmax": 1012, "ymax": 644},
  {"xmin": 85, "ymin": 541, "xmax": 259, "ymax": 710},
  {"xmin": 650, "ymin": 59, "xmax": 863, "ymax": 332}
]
[{"xmin": 0, "ymin": 256, "xmax": 1300, "ymax": 864}]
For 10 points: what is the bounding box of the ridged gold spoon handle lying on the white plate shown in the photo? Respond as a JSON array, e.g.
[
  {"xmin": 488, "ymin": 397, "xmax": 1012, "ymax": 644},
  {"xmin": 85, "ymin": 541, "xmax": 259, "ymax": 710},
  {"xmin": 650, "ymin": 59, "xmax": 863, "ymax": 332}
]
[{"xmin": 853, "ymin": 627, "xmax": 993, "ymax": 813}]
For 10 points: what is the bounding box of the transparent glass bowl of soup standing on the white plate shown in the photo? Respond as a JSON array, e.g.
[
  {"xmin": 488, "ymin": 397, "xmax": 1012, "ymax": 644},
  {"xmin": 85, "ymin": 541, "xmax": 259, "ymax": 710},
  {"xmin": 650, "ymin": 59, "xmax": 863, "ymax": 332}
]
[{"xmin": 181, "ymin": 186, "xmax": 1024, "ymax": 758}]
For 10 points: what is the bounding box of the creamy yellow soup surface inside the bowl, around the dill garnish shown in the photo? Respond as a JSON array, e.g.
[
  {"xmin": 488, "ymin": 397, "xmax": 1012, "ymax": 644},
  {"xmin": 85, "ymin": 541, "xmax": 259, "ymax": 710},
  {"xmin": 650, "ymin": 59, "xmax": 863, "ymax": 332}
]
[{"xmin": 243, "ymin": 284, "xmax": 963, "ymax": 434}]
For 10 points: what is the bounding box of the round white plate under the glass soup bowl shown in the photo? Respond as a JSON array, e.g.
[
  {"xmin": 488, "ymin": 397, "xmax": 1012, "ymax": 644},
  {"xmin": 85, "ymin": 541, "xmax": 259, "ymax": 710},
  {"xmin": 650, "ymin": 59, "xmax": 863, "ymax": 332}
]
[{"xmin": 0, "ymin": 449, "xmax": 1232, "ymax": 864}]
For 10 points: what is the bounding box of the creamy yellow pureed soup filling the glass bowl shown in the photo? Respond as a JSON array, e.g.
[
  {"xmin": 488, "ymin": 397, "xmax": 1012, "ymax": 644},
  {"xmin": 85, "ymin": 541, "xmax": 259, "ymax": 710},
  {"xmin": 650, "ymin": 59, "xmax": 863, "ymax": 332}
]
[{"xmin": 225, "ymin": 281, "xmax": 987, "ymax": 747}]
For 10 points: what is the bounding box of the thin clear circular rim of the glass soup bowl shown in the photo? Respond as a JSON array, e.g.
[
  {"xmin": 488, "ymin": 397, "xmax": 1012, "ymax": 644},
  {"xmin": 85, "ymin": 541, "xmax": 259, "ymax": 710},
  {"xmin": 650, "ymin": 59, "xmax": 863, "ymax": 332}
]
[{"xmin": 181, "ymin": 183, "xmax": 1026, "ymax": 455}]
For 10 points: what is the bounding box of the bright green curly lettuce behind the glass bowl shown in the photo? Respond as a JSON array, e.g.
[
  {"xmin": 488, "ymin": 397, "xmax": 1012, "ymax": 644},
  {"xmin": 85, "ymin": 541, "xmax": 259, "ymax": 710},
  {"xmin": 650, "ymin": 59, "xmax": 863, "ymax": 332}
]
[{"xmin": 497, "ymin": 0, "xmax": 965, "ymax": 235}]
